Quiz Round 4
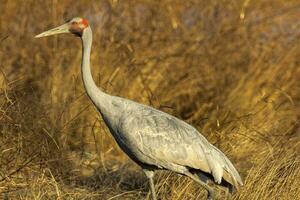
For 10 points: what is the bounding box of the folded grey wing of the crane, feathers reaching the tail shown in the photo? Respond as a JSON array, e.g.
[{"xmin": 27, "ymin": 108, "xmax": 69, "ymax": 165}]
[{"xmin": 118, "ymin": 107, "xmax": 242, "ymax": 187}]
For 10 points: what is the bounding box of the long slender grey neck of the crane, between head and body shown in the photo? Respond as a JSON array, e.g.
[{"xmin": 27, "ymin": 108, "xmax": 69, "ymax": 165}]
[{"xmin": 81, "ymin": 27, "xmax": 109, "ymax": 109}]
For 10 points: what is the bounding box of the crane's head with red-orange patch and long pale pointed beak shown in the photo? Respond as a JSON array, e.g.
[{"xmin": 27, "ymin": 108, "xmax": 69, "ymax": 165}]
[{"xmin": 35, "ymin": 17, "xmax": 89, "ymax": 38}]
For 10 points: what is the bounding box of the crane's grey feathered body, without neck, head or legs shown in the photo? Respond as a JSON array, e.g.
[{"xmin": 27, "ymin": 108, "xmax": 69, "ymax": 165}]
[{"xmin": 95, "ymin": 93, "xmax": 241, "ymax": 185}]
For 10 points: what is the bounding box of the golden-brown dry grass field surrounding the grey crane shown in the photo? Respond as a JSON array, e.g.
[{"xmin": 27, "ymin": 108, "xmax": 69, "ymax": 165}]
[{"xmin": 0, "ymin": 0, "xmax": 300, "ymax": 200}]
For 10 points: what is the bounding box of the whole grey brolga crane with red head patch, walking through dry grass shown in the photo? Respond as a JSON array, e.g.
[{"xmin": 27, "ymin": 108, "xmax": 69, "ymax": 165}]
[{"xmin": 36, "ymin": 17, "xmax": 243, "ymax": 200}]
